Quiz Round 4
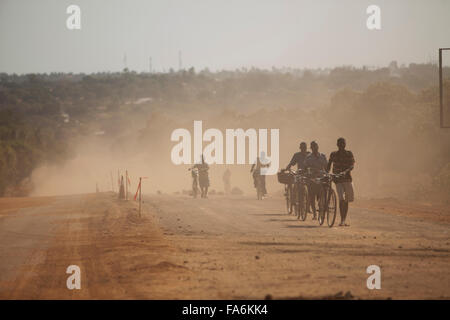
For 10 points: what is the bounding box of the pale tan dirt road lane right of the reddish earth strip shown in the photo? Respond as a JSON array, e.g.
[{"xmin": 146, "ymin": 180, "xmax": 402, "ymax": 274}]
[{"xmin": 142, "ymin": 195, "xmax": 450, "ymax": 299}]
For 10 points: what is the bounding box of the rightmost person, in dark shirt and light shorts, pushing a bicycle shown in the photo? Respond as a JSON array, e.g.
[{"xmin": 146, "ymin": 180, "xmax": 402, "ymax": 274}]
[{"xmin": 327, "ymin": 138, "xmax": 355, "ymax": 226}]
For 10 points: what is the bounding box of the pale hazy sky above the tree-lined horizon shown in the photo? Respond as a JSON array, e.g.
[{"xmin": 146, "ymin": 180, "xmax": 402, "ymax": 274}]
[{"xmin": 0, "ymin": 0, "xmax": 450, "ymax": 73}]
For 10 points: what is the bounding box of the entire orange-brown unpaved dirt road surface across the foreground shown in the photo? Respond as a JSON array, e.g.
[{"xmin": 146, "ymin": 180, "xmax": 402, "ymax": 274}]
[{"xmin": 0, "ymin": 193, "xmax": 450, "ymax": 299}]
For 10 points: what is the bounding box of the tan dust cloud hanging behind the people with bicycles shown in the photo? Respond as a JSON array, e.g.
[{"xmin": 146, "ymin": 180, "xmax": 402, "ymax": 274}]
[{"xmin": 32, "ymin": 81, "xmax": 448, "ymax": 202}]
